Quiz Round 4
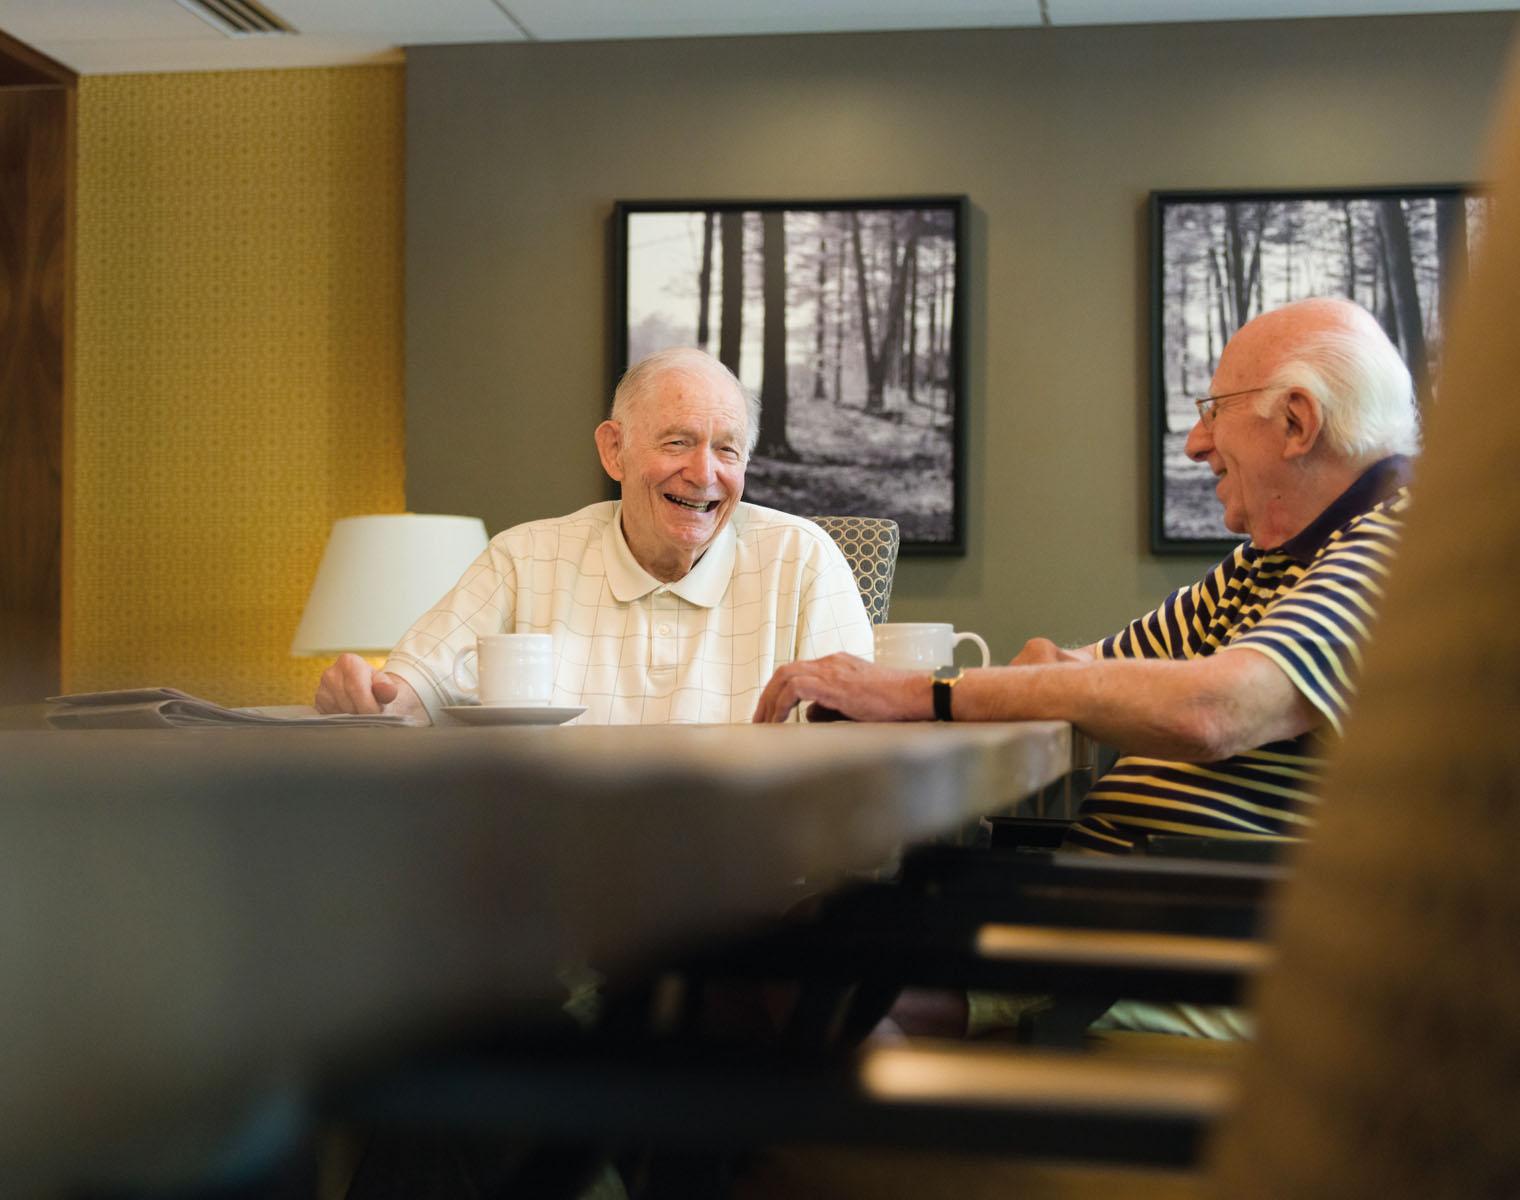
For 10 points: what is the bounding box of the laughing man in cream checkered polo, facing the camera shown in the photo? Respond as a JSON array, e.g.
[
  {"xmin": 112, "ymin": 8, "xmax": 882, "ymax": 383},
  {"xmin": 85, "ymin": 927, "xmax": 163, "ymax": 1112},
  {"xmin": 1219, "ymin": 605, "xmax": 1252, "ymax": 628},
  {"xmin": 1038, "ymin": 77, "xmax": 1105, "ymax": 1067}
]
[{"xmin": 316, "ymin": 350, "xmax": 871, "ymax": 724}]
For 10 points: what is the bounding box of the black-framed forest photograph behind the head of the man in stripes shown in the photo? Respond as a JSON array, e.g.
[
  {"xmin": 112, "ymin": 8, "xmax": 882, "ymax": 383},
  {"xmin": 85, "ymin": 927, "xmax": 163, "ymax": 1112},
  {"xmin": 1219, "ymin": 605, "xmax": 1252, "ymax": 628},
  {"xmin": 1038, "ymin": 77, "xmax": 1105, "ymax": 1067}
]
[{"xmin": 1151, "ymin": 186, "xmax": 1487, "ymax": 557}]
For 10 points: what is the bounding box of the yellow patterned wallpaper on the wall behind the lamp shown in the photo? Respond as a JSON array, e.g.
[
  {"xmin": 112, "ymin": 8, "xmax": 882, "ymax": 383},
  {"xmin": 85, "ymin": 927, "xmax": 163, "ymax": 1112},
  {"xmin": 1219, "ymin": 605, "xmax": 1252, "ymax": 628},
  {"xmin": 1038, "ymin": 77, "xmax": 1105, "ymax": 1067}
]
[{"xmin": 64, "ymin": 65, "xmax": 404, "ymax": 704}]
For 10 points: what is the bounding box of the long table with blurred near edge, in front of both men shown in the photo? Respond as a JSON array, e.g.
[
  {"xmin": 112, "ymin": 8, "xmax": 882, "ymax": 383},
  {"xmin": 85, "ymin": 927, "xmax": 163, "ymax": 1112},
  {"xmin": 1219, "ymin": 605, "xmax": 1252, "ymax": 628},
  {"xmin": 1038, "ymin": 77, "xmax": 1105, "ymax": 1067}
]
[{"xmin": 0, "ymin": 722, "xmax": 1070, "ymax": 1186}]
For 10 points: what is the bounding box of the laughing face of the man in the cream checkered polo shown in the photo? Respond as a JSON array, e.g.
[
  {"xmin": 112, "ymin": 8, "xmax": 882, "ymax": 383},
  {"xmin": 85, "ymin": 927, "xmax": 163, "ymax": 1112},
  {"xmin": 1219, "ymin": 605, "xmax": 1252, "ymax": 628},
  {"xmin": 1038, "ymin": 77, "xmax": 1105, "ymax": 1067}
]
[{"xmin": 596, "ymin": 360, "xmax": 749, "ymax": 583}]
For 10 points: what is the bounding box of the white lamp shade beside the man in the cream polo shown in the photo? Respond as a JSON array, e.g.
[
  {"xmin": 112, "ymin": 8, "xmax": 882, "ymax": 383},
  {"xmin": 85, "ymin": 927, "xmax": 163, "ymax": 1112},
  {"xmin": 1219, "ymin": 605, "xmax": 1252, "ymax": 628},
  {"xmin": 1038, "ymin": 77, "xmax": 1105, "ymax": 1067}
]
[{"xmin": 290, "ymin": 513, "xmax": 486, "ymax": 656}]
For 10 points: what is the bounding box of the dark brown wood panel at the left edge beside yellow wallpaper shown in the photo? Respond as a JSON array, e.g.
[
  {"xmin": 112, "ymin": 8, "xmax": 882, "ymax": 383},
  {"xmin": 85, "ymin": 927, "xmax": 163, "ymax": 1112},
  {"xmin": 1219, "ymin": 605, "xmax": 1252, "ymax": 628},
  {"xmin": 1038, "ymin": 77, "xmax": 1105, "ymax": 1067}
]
[{"xmin": 0, "ymin": 87, "xmax": 70, "ymax": 704}]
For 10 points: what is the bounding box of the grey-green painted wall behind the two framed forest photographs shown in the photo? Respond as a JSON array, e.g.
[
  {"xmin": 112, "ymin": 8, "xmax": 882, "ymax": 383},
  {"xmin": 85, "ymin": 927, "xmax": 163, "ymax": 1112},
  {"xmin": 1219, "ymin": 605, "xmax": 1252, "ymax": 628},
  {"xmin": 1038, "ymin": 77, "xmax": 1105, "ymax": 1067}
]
[{"xmin": 406, "ymin": 14, "xmax": 1515, "ymax": 657}]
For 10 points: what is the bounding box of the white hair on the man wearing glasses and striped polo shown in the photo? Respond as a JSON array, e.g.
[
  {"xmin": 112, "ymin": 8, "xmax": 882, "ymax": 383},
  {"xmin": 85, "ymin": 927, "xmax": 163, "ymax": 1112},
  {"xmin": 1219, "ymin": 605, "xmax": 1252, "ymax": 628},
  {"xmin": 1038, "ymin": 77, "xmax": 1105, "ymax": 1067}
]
[{"xmin": 1271, "ymin": 319, "xmax": 1420, "ymax": 459}]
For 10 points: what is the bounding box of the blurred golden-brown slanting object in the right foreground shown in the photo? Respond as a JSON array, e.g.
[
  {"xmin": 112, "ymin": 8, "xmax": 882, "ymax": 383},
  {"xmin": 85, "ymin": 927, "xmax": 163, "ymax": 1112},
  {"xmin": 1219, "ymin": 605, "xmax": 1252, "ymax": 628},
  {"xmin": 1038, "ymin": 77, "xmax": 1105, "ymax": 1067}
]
[{"xmin": 1214, "ymin": 32, "xmax": 1520, "ymax": 1200}]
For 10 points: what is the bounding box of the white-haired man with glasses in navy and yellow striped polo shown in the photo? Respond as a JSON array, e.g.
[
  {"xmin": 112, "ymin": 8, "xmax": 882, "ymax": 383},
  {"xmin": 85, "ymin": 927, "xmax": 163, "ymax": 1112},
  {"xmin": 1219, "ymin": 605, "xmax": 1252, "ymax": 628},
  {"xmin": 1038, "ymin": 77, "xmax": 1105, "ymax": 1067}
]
[{"xmin": 755, "ymin": 300, "xmax": 1418, "ymax": 852}]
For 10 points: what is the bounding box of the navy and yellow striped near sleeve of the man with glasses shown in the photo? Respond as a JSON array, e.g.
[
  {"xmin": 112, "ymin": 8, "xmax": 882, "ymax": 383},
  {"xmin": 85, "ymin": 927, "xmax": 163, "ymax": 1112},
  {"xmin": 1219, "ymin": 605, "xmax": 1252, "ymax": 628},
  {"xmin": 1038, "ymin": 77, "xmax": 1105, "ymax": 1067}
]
[{"xmin": 1230, "ymin": 503, "xmax": 1403, "ymax": 733}]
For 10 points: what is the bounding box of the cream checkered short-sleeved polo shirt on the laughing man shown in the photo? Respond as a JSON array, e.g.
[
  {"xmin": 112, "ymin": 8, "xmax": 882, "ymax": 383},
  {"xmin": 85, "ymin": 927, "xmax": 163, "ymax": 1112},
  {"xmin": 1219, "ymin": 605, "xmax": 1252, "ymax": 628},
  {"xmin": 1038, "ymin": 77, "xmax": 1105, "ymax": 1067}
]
[{"xmin": 386, "ymin": 500, "xmax": 871, "ymax": 725}]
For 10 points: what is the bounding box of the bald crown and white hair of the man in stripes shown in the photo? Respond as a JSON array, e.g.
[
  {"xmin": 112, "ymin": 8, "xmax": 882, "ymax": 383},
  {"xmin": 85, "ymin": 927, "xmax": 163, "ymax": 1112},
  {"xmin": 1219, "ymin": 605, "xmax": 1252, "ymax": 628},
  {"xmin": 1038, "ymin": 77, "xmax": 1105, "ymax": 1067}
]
[{"xmin": 1221, "ymin": 298, "xmax": 1420, "ymax": 462}]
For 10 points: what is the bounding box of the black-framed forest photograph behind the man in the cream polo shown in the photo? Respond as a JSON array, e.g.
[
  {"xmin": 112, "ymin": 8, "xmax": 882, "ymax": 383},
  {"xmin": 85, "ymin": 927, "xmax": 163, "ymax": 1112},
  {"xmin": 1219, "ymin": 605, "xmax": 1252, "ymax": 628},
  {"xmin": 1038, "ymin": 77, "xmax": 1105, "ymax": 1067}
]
[{"xmin": 613, "ymin": 196, "xmax": 967, "ymax": 554}]
